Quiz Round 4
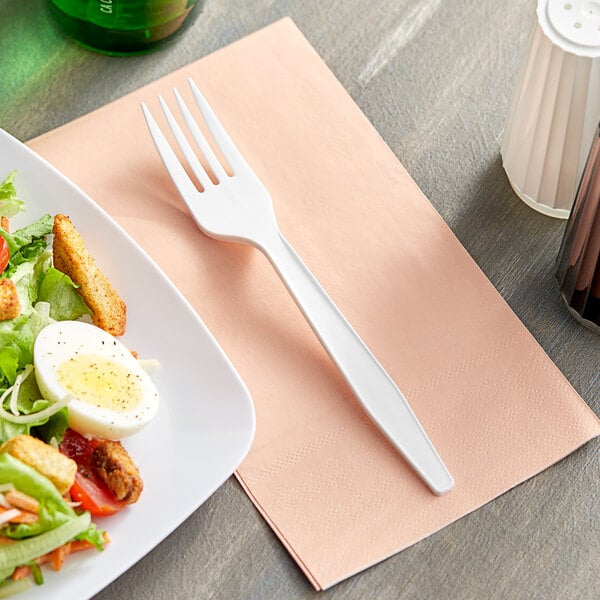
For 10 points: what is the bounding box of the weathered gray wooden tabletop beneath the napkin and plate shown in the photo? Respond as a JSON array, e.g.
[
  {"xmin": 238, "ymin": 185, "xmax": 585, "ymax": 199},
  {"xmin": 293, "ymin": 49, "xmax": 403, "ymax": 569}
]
[{"xmin": 0, "ymin": 0, "xmax": 600, "ymax": 600}]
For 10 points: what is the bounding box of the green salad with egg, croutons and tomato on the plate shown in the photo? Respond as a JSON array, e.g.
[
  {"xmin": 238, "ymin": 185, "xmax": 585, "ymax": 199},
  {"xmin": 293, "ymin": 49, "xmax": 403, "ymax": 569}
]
[{"xmin": 0, "ymin": 172, "xmax": 158, "ymax": 598}]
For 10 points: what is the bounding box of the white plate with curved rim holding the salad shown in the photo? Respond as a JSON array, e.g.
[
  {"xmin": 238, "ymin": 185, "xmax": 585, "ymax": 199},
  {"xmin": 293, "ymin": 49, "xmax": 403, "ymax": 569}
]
[{"xmin": 0, "ymin": 129, "xmax": 255, "ymax": 600}]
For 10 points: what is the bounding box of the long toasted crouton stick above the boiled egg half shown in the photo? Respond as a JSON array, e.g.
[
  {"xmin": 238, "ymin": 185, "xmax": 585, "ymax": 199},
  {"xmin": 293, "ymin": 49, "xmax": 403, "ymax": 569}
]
[{"xmin": 52, "ymin": 215, "xmax": 127, "ymax": 335}]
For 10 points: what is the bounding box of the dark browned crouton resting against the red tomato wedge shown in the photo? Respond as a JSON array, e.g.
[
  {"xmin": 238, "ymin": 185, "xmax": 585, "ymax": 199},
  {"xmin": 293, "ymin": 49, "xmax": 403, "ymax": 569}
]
[{"xmin": 91, "ymin": 440, "xmax": 143, "ymax": 504}]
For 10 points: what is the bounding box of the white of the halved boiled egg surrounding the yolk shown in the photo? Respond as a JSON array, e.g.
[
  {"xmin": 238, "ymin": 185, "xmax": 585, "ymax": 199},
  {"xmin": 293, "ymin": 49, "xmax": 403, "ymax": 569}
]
[{"xmin": 33, "ymin": 321, "xmax": 158, "ymax": 440}]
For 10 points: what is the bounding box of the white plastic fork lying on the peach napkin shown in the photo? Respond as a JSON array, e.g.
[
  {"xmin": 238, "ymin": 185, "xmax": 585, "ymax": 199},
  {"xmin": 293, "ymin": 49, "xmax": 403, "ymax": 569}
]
[{"xmin": 142, "ymin": 79, "xmax": 454, "ymax": 495}]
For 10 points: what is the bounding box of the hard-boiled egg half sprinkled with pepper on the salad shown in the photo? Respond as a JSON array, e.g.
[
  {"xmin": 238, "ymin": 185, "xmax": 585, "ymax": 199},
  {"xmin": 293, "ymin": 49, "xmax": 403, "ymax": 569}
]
[{"xmin": 33, "ymin": 321, "xmax": 158, "ymax": 440}]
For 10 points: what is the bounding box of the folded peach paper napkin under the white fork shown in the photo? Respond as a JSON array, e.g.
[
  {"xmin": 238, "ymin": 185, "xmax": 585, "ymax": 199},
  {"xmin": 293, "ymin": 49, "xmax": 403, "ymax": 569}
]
[{"xmin": 30, "ymin": 19, "xmax": 600, "ymax": 588}]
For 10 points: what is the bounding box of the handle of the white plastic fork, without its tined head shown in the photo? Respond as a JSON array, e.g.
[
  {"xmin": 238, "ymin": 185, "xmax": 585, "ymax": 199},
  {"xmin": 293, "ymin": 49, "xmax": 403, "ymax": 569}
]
[{"xmin": 260, "ymin": 230, "xmax": 454, "ymax": 495}]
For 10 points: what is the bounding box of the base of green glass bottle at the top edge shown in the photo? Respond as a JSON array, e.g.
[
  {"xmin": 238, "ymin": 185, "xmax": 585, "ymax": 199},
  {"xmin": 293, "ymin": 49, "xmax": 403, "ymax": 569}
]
[{"xmin": 49, "ymin": 0, "xmax": 204, "ymax": 55}]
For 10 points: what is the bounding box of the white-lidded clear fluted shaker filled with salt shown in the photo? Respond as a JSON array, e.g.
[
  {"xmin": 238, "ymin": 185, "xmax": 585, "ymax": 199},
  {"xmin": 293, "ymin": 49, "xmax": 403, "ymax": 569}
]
[{"xmin": 501, "ymin": 0, "xmax": 600, "ymax": 219}]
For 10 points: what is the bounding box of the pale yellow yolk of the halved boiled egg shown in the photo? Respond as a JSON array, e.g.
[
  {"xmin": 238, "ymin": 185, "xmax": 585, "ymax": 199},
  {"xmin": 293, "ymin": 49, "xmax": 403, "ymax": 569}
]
[{"xmin": 58, "ymin": 355, "xmax": 142, "ymax": 412}]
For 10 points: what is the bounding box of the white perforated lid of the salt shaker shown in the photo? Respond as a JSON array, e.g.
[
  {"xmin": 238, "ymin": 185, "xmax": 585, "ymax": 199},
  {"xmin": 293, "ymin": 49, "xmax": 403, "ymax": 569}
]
[{"xmin": 537, "ymin": 0, "xmax": 600, "ymax": 58}]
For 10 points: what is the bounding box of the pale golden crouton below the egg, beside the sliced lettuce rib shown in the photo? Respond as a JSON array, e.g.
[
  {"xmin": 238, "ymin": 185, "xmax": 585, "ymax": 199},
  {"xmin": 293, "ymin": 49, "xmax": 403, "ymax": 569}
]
[{"xmin": 0, "ymin": 435, "xmax": 77, "ymax": 494}]
